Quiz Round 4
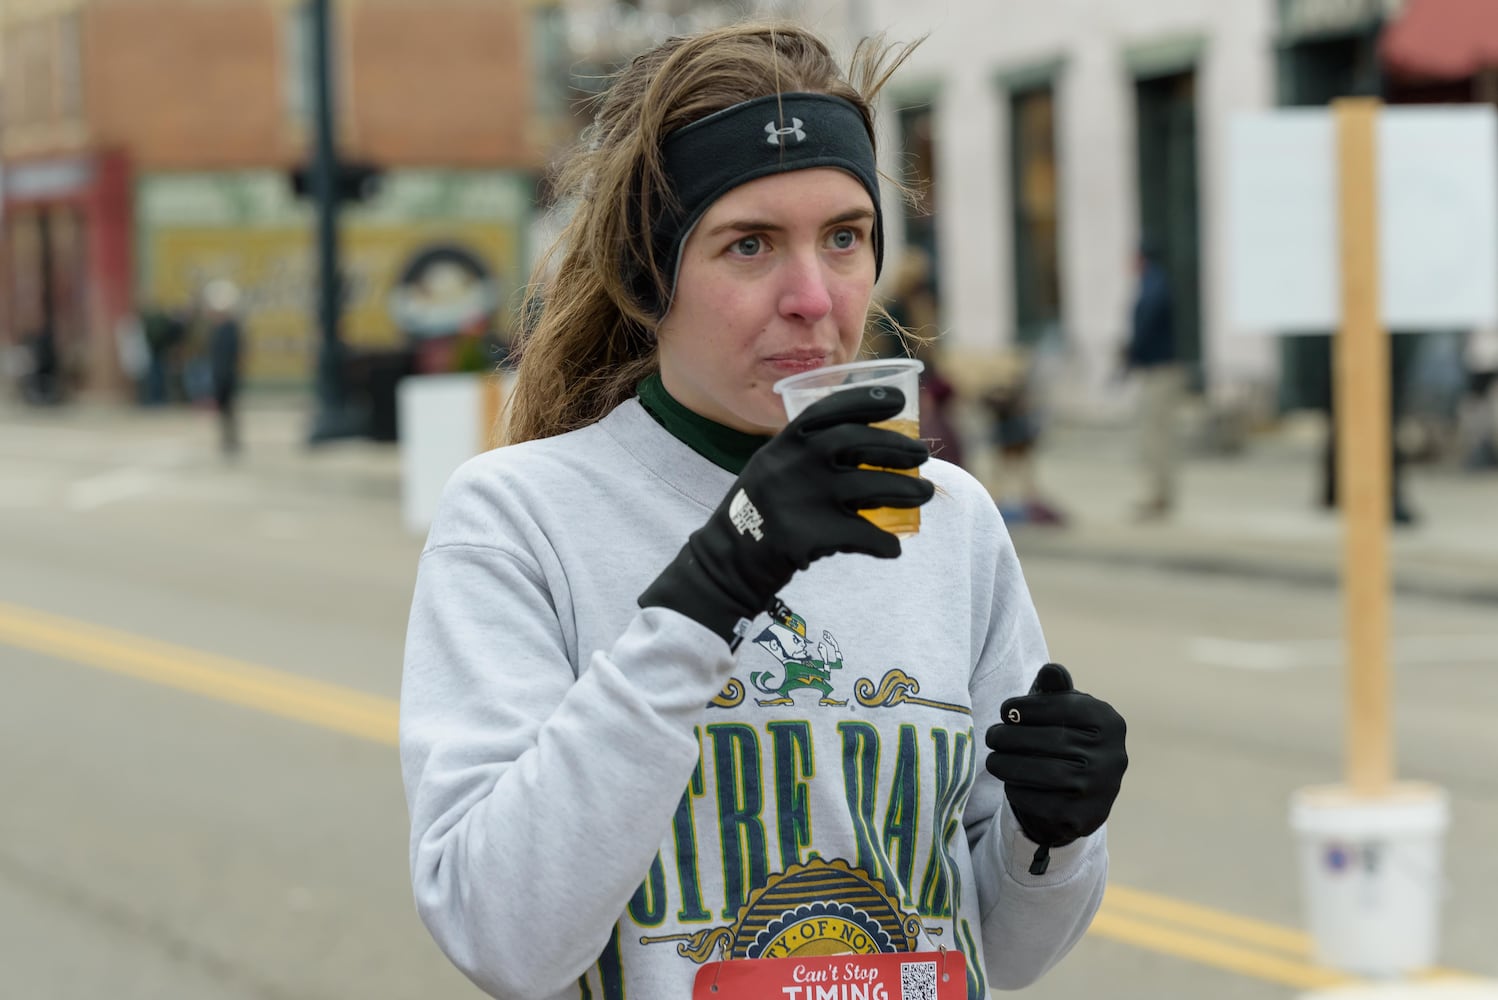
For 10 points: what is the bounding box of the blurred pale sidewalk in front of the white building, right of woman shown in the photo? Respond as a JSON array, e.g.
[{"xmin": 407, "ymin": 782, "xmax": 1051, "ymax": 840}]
[{"xmin": 1013, "ymin": 424, "xmax": 1498, "ymax": 603}]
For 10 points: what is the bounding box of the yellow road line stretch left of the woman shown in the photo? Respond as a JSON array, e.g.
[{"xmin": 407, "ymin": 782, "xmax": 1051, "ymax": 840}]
[{"xmin": 0, "ymin": 602, "xmax": 398, "ymax": 747}]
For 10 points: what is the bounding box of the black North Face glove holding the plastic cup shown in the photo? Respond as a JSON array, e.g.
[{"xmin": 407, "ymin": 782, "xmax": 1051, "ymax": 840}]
[{"xmin": 640, "ymin": 386, "xmax": 933, "ymax": 644}]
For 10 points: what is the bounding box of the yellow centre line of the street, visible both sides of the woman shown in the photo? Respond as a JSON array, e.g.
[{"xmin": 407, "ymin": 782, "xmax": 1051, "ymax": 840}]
[{"xmin": 0, "ymin": 602, "xmax": 1486, "ymax": 990}]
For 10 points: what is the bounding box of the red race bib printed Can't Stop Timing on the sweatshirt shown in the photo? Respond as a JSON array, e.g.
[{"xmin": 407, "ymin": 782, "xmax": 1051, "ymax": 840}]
[{"xmin": 692, "ymin": 951, "xmax": 968, "ymax": 1000}]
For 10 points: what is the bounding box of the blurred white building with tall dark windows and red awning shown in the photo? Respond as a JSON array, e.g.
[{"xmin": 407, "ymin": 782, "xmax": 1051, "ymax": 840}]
[{"xmin": 849, "ymin": 0, "xmax": 1498, "ymax": 412}]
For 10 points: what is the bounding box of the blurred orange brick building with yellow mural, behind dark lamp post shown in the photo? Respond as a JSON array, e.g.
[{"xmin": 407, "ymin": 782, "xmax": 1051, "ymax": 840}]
[{"xmin": 0, "ymin": 0, "xmax": 556, "ymax": 391}]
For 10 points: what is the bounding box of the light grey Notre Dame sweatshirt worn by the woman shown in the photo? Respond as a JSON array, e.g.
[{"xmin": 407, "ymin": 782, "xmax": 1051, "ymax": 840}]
[{"xmin": 400, "ymin": 400, "xmax": 1107, "ymax": 1000}]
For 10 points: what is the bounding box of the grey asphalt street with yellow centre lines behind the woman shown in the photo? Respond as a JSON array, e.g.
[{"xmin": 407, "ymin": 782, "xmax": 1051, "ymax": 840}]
[{"xmin": 0, "ymin": 410, "xmax": 1498, "ymax": 1000}]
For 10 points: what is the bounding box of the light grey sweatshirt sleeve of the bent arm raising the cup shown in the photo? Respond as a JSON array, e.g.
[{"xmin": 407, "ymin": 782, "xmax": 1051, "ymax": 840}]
[{"xmin": 400, "ymin": 476, "xmax": 731, "ymax": 997}]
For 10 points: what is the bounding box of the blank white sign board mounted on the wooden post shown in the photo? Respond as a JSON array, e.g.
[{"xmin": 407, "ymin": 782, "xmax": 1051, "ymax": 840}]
[{"xmin": 1221, "ymin": 106, "xmax": 1498, "ymax": 332}]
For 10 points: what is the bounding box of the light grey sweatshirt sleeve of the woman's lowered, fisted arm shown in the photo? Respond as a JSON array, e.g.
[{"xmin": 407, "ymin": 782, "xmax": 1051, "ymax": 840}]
[{"xmin": 963, "ymin": 514, "xmax": 1107, "ymax": 990}]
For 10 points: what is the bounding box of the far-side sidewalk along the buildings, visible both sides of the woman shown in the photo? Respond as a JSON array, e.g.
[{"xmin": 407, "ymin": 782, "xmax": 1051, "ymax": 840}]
[{"xmin": 11, "ymin": 397, "xmax": 1498, "ymax": 603}]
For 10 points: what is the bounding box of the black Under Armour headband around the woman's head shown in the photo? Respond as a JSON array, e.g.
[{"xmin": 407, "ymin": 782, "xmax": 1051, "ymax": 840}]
[{"xmin": 644, "ymin": 93, "xmax": 884, "ymax": 316}]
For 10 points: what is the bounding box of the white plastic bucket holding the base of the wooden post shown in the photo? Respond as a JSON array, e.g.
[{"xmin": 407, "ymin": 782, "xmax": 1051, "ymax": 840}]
[{"xmin": 1290, "ymin": 783, "xmax": 1449, "ymax": 976}]
